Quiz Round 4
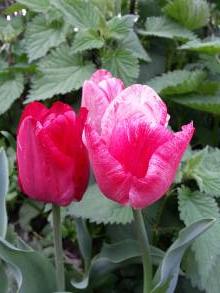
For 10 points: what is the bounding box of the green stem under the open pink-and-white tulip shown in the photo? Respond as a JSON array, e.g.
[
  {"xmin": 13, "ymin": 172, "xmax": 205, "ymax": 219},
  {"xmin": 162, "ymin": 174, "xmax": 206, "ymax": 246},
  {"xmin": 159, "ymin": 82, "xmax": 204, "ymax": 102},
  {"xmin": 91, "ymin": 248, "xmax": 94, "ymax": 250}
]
[{"xmin": 133, "ymin": 209, "xmax": 152, "ymax": 293}]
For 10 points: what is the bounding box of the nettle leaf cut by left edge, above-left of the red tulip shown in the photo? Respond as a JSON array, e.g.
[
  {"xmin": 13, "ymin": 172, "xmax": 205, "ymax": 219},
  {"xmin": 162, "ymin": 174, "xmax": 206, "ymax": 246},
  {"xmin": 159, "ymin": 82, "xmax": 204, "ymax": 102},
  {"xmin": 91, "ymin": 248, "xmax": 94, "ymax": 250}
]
[{"xmin": 0, "ymin": 73, "xmax": 24, "ymax": 115}]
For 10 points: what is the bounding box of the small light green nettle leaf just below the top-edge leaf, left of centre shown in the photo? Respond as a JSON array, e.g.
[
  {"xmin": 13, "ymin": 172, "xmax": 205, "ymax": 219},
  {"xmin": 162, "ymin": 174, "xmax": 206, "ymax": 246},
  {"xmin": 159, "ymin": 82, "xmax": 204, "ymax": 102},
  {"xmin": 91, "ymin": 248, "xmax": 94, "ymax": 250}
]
[{"xmin": 71, "ymin": 29, "xmax": 105, "ymax": 53}]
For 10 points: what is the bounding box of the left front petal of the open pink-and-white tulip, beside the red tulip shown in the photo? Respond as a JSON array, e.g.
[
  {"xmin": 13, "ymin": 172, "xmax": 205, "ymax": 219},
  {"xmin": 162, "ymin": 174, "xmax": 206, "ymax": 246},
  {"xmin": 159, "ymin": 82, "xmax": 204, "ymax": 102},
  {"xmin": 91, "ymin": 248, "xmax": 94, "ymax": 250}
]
[{"xmin": 85, "ymin": 124, "xmax": 132, "ymax": 204}]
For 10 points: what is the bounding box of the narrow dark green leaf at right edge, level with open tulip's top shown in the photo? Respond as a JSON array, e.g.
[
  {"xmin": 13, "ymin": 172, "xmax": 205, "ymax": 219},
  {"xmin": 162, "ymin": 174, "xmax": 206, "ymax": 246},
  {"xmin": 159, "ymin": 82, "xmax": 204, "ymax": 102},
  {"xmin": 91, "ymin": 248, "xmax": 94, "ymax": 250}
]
[{"xmin": 172, "ymin": 93, "xmax": 220, "ymax": 115}]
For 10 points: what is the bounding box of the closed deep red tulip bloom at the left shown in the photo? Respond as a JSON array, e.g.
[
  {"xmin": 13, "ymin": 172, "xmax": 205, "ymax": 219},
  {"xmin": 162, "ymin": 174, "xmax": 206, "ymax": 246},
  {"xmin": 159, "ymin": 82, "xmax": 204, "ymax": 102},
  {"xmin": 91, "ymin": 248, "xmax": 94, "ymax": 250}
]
[{"xmin": 17, "ymin": 102, "xmax": 89, "ymax": 206}]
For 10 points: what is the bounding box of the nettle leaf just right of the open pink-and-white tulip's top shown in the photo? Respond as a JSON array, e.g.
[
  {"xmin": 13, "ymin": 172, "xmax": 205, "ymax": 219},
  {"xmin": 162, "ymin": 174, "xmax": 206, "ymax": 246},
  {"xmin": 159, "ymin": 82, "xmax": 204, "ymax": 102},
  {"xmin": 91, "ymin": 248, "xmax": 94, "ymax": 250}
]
[{"xmin": 148, "ymin": 70, "xmax": 206, "ymax": 95}]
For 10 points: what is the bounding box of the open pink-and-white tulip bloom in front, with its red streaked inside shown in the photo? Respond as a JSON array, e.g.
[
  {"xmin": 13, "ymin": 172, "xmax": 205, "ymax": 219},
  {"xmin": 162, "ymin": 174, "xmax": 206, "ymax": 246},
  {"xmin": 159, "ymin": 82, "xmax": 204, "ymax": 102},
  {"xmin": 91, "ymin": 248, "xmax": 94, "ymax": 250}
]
[{"xmin": 85, "ymin": 85, "xmax": 194, "ymax": 208}]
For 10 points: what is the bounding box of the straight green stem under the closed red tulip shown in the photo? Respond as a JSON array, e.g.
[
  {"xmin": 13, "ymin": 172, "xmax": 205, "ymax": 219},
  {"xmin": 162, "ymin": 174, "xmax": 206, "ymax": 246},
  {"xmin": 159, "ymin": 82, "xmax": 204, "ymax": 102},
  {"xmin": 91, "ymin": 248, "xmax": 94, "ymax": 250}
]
[{"xmin": 52, "ymin": 204, "xmax": 65, "ymax": 292}]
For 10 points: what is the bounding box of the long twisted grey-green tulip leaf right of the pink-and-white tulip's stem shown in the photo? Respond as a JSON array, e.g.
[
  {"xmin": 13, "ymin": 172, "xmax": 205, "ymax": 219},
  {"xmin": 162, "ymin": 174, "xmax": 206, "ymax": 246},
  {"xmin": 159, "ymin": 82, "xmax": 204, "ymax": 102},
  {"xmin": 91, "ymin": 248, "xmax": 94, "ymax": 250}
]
[{"xmin": 152, "ymin": 218, "xmax": 215, "ymax": 293}]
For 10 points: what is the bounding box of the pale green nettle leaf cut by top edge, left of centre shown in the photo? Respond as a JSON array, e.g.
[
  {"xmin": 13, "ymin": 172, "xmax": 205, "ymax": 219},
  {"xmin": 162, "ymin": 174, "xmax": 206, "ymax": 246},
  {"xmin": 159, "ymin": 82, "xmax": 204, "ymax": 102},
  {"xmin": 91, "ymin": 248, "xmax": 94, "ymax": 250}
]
[{"xmin": 52, "ymin": 0, "xmax": 101, "ymax": 29}]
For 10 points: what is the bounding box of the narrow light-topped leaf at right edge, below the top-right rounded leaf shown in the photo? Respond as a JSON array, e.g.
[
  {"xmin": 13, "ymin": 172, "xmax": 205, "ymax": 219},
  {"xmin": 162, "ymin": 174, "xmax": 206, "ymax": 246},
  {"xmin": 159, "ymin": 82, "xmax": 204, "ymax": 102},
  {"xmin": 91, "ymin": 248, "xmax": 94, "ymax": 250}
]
[{"xmin": 179, "ymin": 37, "xmax": 220, "ymax": 55}]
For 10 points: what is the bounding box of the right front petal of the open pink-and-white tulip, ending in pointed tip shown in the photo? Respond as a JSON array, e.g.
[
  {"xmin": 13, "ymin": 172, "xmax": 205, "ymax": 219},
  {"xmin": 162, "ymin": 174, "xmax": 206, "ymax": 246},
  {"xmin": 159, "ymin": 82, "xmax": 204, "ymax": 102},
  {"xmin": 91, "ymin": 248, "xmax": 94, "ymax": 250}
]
[{"xmin": 129, "ymin": 123, "xmax": 194, "ymax": 208}]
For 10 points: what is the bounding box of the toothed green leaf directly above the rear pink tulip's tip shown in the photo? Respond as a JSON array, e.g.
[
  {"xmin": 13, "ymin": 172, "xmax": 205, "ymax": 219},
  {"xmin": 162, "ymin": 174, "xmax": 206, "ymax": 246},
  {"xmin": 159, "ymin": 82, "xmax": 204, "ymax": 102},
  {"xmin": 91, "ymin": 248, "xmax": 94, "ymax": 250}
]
[{"xmin": 102, "ymin": 49, "xmax": 139, "ymax": 85}]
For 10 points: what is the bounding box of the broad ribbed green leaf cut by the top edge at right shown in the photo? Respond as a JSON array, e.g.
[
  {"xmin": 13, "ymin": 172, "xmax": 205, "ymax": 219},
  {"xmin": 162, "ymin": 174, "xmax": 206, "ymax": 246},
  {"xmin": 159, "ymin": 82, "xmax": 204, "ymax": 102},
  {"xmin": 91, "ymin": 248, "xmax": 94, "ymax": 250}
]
[{"xmin": 163, "ymin": 0, "xmax": 210, "ymax": 30}]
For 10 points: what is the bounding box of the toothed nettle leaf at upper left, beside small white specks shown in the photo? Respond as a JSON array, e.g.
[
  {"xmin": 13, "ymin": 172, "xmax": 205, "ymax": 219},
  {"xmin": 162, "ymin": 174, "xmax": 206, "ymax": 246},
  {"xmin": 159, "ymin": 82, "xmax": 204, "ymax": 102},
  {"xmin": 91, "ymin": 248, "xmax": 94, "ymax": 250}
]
[{"xmin": 25, "ymin": 15, "xmax": 68, "ymax": 62}]
